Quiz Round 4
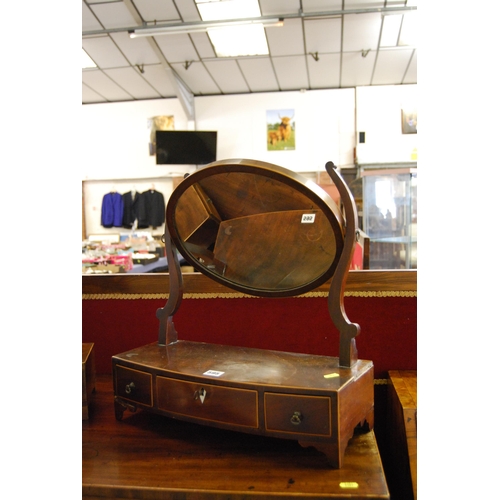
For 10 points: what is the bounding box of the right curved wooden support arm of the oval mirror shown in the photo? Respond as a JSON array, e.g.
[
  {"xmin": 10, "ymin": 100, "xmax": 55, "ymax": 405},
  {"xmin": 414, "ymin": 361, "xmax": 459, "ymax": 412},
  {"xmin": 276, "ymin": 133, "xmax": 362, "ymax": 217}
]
[{"xmin": 325, "ymin": 161, "xmax": 360, "ymax": 368}]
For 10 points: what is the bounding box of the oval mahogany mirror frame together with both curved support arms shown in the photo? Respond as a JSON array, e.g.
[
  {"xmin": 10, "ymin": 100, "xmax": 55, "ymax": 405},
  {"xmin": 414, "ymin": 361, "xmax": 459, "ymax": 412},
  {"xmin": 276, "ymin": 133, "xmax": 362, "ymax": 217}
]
[{"xmin": 156, "ymin": 159, "xmax": 360, "ymax": 367}]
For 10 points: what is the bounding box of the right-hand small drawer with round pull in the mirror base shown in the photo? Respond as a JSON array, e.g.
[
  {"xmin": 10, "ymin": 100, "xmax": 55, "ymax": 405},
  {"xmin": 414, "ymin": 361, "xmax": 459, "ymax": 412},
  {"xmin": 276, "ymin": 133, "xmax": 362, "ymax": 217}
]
[{"xmin": 264, "ymin": 392, "xmax": 332, "ymax": 436}]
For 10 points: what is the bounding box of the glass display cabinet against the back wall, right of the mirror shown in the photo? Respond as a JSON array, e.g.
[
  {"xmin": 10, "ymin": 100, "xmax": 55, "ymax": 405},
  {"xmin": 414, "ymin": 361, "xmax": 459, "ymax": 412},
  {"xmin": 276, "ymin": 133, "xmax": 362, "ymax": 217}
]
[{"xmin": 361, "ymin": 168, "xmax": 417, "ymax": 269}]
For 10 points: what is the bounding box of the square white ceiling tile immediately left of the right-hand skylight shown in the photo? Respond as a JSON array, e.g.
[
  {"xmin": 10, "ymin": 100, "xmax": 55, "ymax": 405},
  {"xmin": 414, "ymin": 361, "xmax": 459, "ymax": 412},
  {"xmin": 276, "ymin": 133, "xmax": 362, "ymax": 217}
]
[{"xmin": 343, "ymin": 14, "xmax": 382, "ymax": 52}]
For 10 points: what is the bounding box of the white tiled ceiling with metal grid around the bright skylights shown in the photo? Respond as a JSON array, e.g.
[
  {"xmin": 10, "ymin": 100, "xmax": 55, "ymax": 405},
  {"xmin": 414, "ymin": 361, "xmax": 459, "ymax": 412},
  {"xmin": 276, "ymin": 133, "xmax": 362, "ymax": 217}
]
[{"xmin": 82, "ymin": 0, "xmax": 417, "ymax": 104}]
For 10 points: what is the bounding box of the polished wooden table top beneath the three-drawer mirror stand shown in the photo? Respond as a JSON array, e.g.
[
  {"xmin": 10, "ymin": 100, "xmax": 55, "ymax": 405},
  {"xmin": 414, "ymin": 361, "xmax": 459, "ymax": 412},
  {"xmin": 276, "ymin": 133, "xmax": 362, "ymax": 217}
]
[{"xmin": 82, "ymin": 375, "xmax": 389, "ymax": 500}]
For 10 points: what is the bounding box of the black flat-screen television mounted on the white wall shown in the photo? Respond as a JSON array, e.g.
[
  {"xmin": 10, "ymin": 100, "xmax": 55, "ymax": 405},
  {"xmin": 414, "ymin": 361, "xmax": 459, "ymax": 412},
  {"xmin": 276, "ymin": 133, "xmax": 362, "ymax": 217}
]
[{"xmin": 156, "ymin": 130, "xmax": 217, "ymax": 165}]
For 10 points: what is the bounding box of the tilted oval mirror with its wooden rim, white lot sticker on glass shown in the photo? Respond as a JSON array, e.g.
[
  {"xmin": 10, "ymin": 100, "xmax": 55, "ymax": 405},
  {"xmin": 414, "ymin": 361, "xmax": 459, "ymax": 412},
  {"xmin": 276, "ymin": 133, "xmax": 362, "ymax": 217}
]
[{"xmin": 166, "ymin": 160, "xmax": 343, "ymax": 296}]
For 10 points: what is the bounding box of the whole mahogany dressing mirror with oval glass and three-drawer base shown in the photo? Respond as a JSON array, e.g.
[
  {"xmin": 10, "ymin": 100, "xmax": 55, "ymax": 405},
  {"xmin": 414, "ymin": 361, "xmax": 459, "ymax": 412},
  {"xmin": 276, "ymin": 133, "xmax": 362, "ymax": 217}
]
[{"xmin": 112, "ymin": 160, "xmax": 374, "ymax": 468}]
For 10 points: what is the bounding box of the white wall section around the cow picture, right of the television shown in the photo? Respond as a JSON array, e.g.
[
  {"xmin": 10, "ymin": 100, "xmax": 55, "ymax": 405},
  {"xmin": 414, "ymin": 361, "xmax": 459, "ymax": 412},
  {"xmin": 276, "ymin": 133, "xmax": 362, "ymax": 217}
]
[{"xmin": 195, "ymin": 89, "xmax": 355, "ymax": 172}]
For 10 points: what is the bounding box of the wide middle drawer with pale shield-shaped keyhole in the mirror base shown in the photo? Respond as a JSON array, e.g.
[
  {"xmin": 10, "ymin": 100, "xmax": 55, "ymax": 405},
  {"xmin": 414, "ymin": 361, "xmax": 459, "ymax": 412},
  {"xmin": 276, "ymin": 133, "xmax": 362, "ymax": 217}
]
[{"xmin": 156, "ymin": 377, "xmax": 258, "ymax": 428}]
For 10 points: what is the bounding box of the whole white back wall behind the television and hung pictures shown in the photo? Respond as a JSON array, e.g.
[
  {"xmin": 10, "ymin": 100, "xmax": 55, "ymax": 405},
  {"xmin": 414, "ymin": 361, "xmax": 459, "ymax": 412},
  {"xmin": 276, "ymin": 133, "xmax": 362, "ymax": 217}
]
[{"xmin": 80, "ymin": 85, "xmax": 417, "ymax": 234}]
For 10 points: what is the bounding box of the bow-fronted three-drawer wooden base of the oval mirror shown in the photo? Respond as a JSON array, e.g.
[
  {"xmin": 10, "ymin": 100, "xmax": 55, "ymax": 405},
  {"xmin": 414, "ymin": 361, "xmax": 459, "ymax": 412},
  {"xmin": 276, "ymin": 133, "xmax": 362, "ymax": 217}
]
[{"xmin": 112, "ymin": 341, "xmax": 374, "ymax": 469}]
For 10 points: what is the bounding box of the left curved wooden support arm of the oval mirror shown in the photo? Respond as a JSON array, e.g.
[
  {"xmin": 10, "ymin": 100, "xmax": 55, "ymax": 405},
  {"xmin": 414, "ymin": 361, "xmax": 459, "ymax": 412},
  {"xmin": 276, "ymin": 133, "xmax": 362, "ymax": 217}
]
[{"xmin": 156, "ymin": 228, "xmax": 183, "ymax": 345}]
